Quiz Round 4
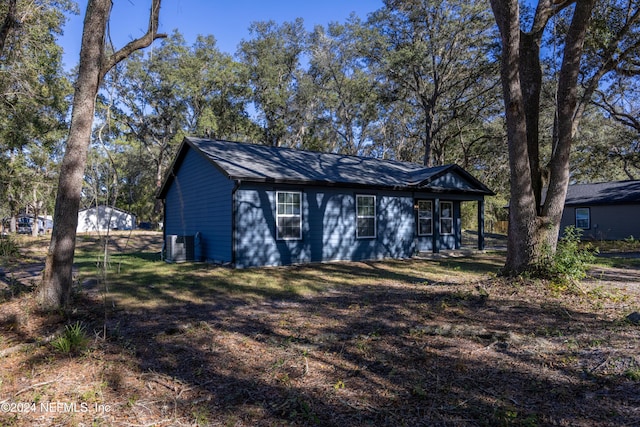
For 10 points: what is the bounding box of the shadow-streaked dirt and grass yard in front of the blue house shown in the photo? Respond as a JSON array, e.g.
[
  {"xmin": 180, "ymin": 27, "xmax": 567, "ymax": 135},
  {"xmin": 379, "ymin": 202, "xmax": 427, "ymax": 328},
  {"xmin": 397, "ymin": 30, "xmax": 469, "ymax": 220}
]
[{"xmin": 0, "ymin": 233, "xmax": 640, "ymax": 426}]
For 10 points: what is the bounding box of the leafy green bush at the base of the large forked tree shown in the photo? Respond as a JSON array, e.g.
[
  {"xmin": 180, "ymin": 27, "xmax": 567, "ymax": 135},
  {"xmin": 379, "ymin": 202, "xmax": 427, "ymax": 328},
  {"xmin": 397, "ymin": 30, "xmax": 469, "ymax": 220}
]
[{"xmin": 536, "ymin": 226, "xmax": 597, "ymax": 291}]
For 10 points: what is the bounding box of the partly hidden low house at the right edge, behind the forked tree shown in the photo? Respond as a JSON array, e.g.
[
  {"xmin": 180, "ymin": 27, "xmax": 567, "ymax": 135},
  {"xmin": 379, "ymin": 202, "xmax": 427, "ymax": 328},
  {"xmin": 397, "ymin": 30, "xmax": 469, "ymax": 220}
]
[{"xmin": 560, "ymin": 181, "xmax": 640, "ymax": 240}]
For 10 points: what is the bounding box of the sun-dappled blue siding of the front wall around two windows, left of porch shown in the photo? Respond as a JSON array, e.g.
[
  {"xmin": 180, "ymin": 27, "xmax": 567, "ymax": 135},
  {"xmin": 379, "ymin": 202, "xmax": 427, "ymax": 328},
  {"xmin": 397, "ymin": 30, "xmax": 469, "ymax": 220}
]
[{"xmin": 236, "ymin": 184, "xmax": 415, "ymax": 267}]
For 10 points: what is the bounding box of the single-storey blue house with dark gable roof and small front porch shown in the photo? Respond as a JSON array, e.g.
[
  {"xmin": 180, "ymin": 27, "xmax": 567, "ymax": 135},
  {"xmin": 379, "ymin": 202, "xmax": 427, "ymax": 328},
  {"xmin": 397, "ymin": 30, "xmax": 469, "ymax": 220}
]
[{"xmin": 158, "ymin": 138, "xmax": 493, "ymax": 267}]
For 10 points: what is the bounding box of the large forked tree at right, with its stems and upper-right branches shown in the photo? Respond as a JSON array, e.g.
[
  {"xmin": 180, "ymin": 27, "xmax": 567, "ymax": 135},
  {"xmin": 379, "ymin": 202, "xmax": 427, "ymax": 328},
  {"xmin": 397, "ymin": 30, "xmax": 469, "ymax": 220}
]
[{"xmin": 491, "ymin": 0, "xmax": 638, "ymax": 274}]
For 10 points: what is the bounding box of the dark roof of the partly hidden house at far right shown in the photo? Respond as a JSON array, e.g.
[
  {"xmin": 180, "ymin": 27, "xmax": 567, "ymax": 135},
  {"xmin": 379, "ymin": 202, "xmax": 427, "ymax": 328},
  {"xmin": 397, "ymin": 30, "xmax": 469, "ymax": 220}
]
[{"xmin": 565, "ymin": 181, "xmax": 640, "ymax": 206}]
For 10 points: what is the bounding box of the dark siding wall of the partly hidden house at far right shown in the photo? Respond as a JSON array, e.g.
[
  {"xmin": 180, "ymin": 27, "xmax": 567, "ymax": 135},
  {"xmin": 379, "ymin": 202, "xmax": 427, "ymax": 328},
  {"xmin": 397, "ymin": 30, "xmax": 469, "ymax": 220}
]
[{"xmin": 560, "ymin": 204, "xmax": 640, "ymax": 240}]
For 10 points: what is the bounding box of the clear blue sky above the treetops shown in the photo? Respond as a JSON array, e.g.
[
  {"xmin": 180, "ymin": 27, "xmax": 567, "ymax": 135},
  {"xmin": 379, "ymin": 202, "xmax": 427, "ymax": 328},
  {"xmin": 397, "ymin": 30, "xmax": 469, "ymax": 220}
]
[{"xmin": 59, "ymin": 0, "xmax": 382, "ymax": 69}]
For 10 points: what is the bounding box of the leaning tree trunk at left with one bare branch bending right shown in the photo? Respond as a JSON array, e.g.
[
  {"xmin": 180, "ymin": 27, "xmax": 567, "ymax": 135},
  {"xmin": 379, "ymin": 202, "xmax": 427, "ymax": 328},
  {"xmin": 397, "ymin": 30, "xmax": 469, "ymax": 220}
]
[{"xmin": 39, "ymin": 0, "xmax": 164, "ymax": 308}]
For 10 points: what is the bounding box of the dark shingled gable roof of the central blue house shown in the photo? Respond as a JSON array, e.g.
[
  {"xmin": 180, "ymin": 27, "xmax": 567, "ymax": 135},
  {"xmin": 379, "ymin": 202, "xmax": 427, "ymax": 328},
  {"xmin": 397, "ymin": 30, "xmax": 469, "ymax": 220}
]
[{"xmin": 158, "ymin": 137, "xmax": 494, "ymax": 198}]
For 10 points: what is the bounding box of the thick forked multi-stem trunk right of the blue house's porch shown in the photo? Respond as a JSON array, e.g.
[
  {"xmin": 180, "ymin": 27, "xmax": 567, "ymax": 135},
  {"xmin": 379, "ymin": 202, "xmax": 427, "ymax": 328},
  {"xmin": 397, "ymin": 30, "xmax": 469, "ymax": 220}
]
[{"xmin": 491, "ymin": 0, "xmax": 595, "ymax": 274}]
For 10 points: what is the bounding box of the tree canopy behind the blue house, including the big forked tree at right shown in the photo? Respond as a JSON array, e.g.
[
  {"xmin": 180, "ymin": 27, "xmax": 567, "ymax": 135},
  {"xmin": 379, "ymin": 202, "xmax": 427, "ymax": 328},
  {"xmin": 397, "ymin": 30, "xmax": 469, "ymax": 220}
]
[{"xmin": 0, "ymin": 0, "xmax": 640, "ymax": 290}]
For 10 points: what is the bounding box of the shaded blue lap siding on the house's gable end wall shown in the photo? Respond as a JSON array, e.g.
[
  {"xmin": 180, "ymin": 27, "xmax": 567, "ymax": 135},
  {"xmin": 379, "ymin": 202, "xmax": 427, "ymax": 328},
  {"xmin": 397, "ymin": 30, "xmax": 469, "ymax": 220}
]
[{"xmin": 165, "ymin": 150, "xmax": 234, "ymax": 263}]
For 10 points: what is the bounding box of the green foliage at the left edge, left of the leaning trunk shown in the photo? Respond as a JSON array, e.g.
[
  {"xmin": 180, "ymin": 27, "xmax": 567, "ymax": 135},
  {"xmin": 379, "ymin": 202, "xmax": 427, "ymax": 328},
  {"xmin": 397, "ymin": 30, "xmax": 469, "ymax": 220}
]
[{"xmin": 0, "ymin": 0, "xmax": 77, "ymax": 226}]
